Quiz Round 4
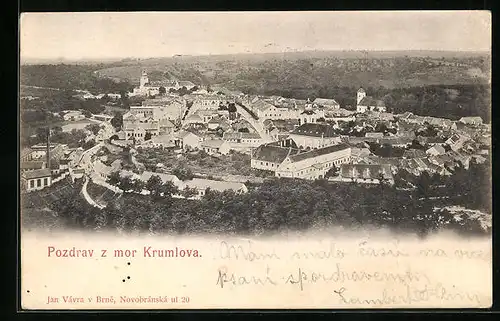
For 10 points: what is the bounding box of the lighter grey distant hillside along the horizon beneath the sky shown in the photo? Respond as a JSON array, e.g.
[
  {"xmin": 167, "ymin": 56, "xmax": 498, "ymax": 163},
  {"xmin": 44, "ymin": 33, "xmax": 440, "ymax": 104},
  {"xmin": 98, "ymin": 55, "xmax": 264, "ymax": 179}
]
[{"xmin": 97, "ymin": 51, "xmax": 490, "ymax": 93}]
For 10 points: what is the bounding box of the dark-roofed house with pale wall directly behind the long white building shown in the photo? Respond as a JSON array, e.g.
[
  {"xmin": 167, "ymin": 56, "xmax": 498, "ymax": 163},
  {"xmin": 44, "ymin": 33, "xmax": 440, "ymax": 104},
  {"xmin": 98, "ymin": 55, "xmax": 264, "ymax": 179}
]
[{"xmin": 289, "ymin": 123, "xmax": 341, "ymax": 149}]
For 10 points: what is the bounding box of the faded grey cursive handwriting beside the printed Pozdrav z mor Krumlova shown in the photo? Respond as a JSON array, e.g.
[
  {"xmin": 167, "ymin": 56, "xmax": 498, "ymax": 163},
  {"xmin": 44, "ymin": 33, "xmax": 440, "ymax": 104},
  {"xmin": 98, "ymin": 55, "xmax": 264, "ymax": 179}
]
[{"xmin": 213, "ymin": 235, "xmax": 492, "ymax": 308}]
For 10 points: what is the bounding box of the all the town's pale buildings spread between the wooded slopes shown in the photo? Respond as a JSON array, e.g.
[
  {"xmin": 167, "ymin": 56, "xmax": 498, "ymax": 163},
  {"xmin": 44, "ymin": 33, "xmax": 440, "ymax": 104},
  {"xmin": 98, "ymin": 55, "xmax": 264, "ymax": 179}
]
[{"xmin": 21, "ymin": 72, "xmax": 491, "ymax": 197}]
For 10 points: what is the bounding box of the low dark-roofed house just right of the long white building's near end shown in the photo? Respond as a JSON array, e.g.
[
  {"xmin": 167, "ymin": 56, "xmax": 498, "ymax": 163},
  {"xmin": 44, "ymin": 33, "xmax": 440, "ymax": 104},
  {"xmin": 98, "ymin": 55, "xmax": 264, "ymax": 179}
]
[{"xmin": 338, "ymin": 164, "xmax": 394, "ymax": 184}]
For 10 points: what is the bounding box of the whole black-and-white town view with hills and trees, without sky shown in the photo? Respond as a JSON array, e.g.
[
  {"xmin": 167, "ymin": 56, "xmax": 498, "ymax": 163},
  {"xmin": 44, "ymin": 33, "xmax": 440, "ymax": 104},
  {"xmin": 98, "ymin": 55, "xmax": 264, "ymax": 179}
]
[{"xmin": 20, "ymin": 51, "xmax": 492, "ymax": 236}]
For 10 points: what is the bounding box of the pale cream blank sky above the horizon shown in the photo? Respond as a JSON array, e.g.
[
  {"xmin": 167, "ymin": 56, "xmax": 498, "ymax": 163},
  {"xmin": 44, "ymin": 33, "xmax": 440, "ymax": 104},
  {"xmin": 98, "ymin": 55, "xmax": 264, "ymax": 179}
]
[{"xmin": 20, "ymin": 11, "xmax": 491, "ymax": 59}]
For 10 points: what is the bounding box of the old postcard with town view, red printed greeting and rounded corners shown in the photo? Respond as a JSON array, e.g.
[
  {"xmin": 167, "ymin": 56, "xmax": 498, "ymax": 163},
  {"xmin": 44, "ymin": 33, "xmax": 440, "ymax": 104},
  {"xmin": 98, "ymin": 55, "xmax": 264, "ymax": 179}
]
[{"xmin": 19, "ymin": 11, "xmax": 492, "ymax": 310}]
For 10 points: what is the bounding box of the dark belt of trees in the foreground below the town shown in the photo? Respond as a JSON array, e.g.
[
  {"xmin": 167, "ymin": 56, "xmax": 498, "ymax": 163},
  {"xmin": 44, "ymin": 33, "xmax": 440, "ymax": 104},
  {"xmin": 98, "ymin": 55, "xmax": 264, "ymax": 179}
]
[{"xmin": 23, "ymin": 160, "xmax": 491, "ymax": 236}]
